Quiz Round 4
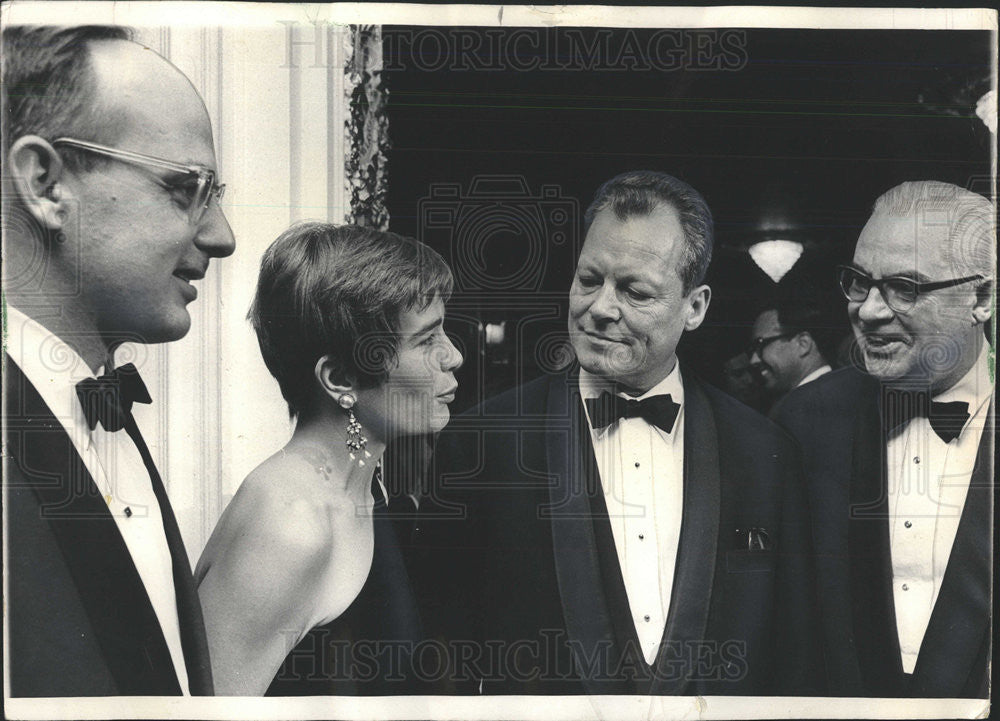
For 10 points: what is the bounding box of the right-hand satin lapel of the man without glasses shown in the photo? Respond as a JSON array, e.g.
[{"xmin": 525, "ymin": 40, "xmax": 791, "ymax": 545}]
[{"xmin": 650, "ymin": 373, "xmax": 722, "ymax": 695}]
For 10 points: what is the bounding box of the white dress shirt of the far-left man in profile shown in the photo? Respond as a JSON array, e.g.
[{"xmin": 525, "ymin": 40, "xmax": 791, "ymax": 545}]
[{"xmin": 6, "ymin": 305, "xmax": 190, "ymax": 695}]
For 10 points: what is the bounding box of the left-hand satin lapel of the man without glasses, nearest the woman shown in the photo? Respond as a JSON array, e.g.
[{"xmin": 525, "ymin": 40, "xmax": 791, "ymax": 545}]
[{"xmin": 542, "ymin": 376, "xmax": 632, "ymax": 694}]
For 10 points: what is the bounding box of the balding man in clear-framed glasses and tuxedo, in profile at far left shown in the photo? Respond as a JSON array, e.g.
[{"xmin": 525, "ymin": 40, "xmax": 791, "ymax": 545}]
[{"xmin": 3, "ymin": 26, "xmax": 234, "ymax": 697}]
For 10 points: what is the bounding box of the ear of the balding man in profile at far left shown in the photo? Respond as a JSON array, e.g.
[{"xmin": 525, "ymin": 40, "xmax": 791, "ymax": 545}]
[{"xmin": 7, "ymin": 135, "xmax": 68, "ymax": 231}]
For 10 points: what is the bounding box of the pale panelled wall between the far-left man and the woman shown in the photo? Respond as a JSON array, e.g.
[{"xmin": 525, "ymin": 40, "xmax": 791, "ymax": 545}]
[{"xmin": 122, "ymin": 23, "xmax": 356, "ymax": 564}]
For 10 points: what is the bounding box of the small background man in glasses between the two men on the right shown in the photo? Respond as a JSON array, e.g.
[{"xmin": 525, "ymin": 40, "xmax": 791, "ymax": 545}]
[{"xmin": 747, "ymin": 300, "xmax": 831, "ymax": 402}]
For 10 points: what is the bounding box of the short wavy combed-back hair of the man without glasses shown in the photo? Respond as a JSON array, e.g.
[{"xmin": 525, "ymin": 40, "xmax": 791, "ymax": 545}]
[{"xmin": 583, "ymin": 170, "xmax": 714, "ymax": 293}]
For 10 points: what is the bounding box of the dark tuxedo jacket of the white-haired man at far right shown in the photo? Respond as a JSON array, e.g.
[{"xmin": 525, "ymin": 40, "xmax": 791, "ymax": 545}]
[{"xmin": 773, "ymin": 368, "xmax": 994, "ymax": 698}]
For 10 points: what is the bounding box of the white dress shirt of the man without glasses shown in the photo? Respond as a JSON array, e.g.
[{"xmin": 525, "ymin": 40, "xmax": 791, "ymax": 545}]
[{"xmin": 580, "ymin": 363, "xmax": 684, "ymax": 664}]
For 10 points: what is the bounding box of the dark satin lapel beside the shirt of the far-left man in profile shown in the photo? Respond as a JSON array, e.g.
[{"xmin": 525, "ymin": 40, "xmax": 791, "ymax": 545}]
[{"xmin": 5, "ymin": 357, "xmax": 181, "ymax": 695}]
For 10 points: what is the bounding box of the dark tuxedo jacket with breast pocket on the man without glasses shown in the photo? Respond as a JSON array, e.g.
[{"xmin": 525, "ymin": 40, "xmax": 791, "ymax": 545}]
[{"xmin": 414, "ymin": 372, "xmax": 818, "ymax": 694}]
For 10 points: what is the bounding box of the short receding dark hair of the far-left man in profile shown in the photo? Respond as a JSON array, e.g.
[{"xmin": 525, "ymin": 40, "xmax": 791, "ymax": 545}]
[{"xmin": 0, "ymin": 25, "xmax": 133, "ymax": 167}]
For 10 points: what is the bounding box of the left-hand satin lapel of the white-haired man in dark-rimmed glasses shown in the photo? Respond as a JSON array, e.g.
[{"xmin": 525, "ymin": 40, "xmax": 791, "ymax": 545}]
[{"xmin": 848, "ymin": 385, "xmax": 904, "ymax": 696}]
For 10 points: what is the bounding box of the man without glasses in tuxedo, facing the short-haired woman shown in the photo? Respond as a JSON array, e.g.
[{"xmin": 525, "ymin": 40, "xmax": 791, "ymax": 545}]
[{"xmin": 414, "ymin": 171, "xmax": 815, "ymax": 694}]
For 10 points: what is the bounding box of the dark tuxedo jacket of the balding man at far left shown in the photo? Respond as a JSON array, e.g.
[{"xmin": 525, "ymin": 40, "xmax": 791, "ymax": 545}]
[{"xmin": 4, "ymin": 357, "xmax": 211, "ymax": 697}]
